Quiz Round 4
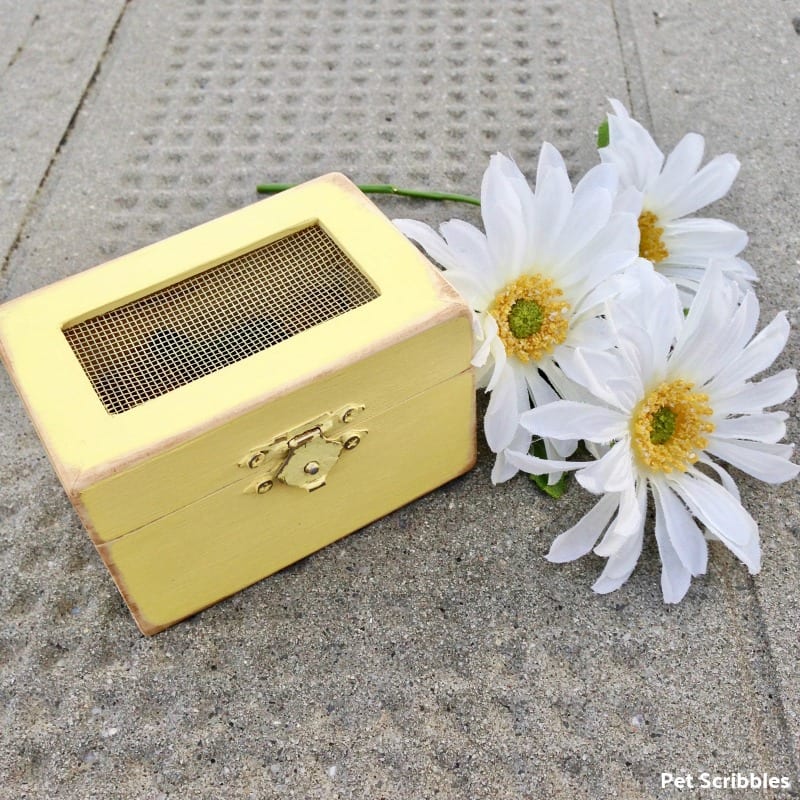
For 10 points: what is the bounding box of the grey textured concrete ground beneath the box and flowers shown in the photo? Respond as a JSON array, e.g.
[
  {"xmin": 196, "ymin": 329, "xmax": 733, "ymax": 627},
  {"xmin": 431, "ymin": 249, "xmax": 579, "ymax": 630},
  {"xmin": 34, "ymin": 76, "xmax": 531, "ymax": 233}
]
[{"xmin": 0, "ymin": 0, "xmax": 800, "ymax": 800}]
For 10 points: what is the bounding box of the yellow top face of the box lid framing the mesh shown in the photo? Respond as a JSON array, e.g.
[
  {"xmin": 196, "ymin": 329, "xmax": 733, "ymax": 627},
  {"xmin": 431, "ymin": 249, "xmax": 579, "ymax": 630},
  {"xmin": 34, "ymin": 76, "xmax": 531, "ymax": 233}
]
[{"xmin": 0, "ymin": 174, "xmax": 470, "ymax": 497}]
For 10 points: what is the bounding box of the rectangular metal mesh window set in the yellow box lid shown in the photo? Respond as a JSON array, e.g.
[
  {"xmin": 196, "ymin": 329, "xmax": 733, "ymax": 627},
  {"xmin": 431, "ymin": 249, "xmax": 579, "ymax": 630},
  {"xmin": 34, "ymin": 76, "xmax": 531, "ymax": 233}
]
[{"xmin": 64, "ymin": 225, "xmax": 378, "ymax": 414}]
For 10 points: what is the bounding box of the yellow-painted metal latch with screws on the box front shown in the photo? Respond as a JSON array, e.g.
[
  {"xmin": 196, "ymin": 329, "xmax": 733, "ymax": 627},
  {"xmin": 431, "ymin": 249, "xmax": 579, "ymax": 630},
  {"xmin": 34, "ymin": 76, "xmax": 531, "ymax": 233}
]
[{"xmin": 239, "ymin": 403, "xmax": 367, "ymax": 494}]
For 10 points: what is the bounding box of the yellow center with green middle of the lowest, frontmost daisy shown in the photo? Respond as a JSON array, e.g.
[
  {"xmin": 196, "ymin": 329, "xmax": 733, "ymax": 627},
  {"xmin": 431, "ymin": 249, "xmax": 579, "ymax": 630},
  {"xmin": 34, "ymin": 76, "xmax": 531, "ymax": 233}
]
[{"xmin": 631, "ymin": 380, "xmax": 714, "ymax": 472}]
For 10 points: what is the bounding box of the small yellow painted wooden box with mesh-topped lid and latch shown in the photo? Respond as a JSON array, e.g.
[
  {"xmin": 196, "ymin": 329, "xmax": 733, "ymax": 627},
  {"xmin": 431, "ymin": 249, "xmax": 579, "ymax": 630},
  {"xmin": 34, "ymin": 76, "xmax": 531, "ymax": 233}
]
[{"xmin": 0, "ymin": 175, "xmax": 475, "ymax": 634}]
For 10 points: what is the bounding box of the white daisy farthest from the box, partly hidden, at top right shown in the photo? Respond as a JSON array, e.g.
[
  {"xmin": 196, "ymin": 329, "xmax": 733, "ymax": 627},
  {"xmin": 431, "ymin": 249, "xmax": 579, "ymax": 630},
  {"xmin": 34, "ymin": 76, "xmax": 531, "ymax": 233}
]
[{"xmin": 599, "ymin": 100, "xmax": 756, "ymax": 306}]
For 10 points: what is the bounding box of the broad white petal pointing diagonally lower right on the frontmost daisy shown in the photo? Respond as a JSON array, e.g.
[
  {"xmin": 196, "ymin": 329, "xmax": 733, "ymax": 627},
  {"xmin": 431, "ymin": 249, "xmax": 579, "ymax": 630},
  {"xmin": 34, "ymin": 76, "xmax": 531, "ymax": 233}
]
[{"xmin": 668, "ymin": 470, "xmax": 761, "ymax": 575}]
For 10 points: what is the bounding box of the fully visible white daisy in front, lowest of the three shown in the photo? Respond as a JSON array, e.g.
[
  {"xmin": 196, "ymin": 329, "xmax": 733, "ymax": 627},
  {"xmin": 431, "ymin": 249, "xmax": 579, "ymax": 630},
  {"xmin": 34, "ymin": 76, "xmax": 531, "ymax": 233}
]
[{"xmin": 508, "ymin": 264, "xmax": 800, "ymax": 603}]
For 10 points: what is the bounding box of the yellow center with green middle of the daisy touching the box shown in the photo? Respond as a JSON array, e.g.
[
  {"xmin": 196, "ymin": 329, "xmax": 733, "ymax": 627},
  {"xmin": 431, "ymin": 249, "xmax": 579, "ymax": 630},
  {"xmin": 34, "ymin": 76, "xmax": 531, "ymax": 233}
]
[{"xmin": 489, "ymin": 274, "xmax": 569, "ymax": 362}]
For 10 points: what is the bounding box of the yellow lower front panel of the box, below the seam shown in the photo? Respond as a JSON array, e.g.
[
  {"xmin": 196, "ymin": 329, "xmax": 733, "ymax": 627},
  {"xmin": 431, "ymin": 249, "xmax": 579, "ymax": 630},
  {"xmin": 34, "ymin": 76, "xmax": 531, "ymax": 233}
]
[{"xmin": 98, "ymin": 370, "xmax": 475, "ymax": 633}]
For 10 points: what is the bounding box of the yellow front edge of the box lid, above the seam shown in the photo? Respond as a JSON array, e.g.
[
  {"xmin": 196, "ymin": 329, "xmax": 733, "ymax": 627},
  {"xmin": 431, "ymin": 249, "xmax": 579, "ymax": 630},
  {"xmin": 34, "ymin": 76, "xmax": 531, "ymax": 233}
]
[{"xmin": 78, "ymin": 315, "xmax": 472, "ymax": 542}]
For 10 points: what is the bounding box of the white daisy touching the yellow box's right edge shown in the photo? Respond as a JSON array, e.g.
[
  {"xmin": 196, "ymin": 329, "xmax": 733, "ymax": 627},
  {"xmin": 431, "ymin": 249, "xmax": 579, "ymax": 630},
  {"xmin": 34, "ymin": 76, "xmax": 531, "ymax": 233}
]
[{"xmin": 395, "ymin": 144, "xmax": 637, "ymax": 483}]
